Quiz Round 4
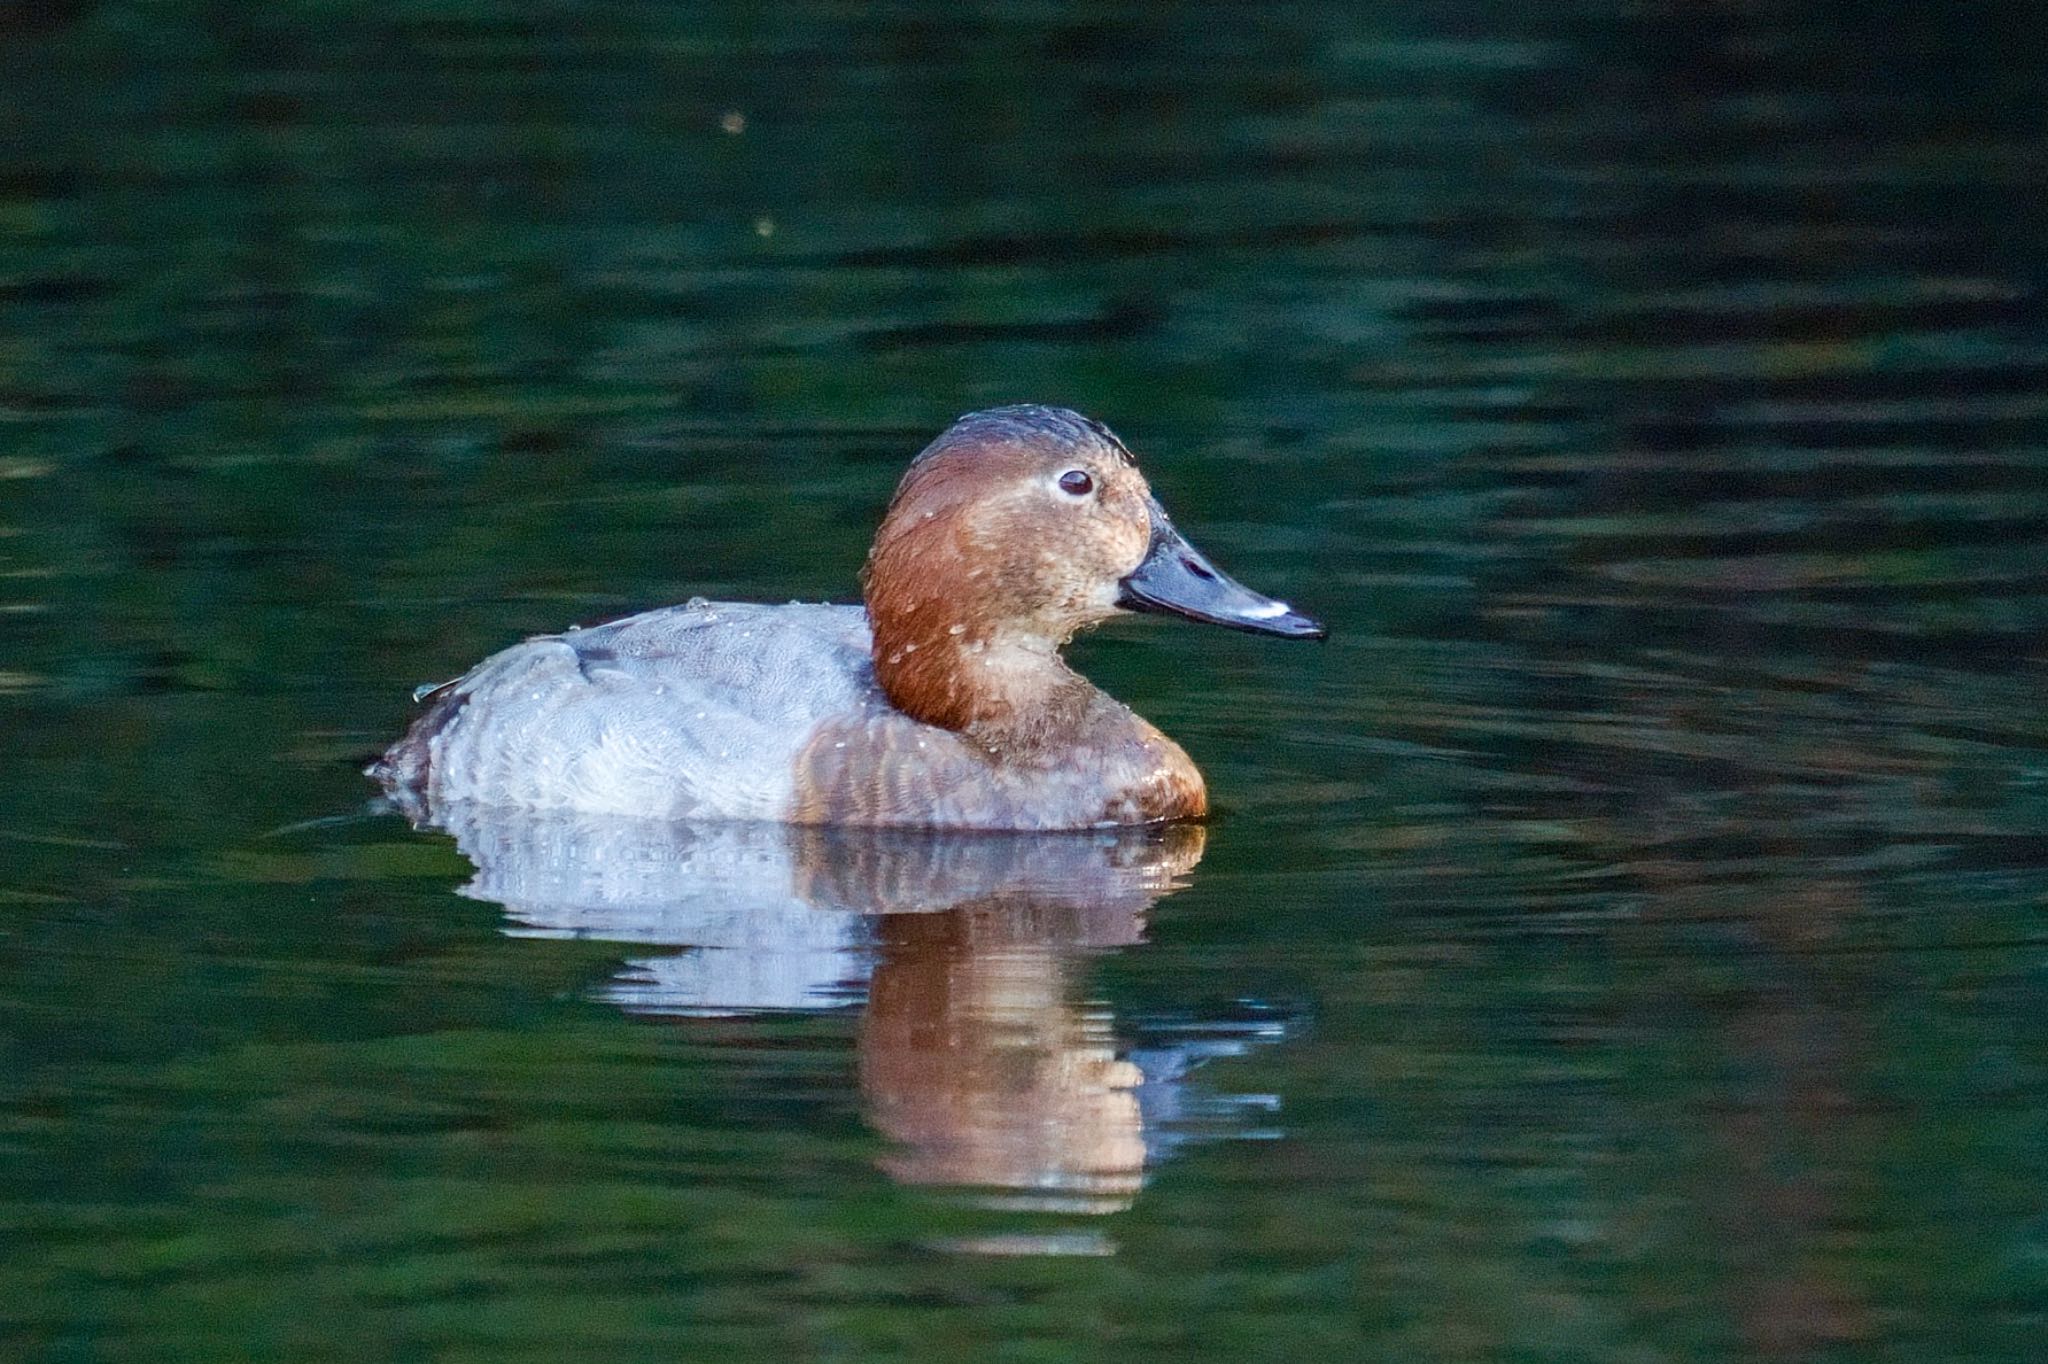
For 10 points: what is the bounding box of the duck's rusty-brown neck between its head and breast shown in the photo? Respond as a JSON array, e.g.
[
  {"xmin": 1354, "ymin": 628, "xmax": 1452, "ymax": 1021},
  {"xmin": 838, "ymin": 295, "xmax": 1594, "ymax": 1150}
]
[{"xmin": 868, "ymin": 612, "xmax": 1102, "ymax": 764}]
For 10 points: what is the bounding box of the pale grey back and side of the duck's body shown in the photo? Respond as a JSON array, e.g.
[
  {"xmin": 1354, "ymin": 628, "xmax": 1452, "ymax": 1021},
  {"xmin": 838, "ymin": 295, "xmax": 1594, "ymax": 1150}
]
[{"xmin": 373, "ymin": 600, "xmax": 889, "ymax": 819}]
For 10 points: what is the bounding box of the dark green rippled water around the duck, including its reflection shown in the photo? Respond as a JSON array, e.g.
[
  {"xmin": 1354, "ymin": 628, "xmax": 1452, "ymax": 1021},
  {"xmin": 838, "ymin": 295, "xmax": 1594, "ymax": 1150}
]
[{"xmin": 0, "ymin": 0, "xmax": 2048, "ymax": 1364}]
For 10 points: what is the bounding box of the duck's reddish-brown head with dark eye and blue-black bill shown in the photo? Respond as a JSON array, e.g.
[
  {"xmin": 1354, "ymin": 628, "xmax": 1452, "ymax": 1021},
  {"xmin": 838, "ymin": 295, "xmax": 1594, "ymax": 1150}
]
[{"xmin": 862, "ymin": 406, "xmax": 1323, "ymax": 727}]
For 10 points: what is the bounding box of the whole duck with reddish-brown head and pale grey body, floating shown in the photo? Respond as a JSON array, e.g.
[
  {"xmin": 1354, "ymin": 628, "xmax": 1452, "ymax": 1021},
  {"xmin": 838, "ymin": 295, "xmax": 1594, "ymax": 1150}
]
[{"xmin": 369, "ymin": 403, "xmax": 1325, "ymax": 832}]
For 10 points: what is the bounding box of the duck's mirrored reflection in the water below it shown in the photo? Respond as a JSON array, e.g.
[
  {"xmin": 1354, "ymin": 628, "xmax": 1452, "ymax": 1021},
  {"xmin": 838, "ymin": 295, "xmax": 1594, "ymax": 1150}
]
[{"xmin": 423, "ymin": 809, "xmax": 1288, "ymax": 1212}]
